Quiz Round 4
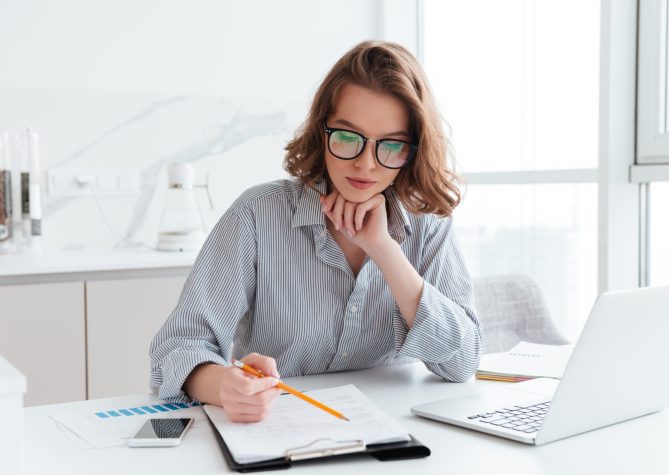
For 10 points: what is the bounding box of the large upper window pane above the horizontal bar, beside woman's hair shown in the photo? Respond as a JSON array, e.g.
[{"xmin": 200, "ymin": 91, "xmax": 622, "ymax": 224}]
[{"xmin": 424, "ymin": 0, "xmax": 600, "ymax": 173}]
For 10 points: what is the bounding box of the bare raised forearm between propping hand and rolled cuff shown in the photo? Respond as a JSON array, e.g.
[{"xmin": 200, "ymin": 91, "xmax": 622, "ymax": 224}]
[{"xmin": 368, "ymin": 239, "xmax": 423, "ymax": 328}]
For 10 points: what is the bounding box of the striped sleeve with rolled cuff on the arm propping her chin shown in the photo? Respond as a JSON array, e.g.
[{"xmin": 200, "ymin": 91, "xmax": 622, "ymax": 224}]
[{"xmin": 393, "ymin": 218, "xmax": 483, "ymax": 382}]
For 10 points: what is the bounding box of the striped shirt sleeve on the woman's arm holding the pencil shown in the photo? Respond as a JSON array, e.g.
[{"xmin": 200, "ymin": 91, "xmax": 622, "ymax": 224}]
[{"xmin": 150, "ymin": 208, "xmax": 256, "ymax": 402}]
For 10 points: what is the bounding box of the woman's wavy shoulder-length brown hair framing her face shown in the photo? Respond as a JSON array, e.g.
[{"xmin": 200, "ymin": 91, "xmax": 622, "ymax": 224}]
[{"xmin": 283, "ymin": 41, "xmax": 461, "ymax": 216}]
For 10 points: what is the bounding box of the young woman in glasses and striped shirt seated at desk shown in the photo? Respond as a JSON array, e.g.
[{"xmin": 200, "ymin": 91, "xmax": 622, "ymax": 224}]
[{"xmin": 151, "ymin": 42, "xmax": 483, "ymax": 421}]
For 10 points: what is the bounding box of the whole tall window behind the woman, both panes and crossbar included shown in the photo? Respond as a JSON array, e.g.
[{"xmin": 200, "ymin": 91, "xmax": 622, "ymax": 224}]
[{"xmin": 422, "ymin": 0, "xmax": 601, "ymax": 339}]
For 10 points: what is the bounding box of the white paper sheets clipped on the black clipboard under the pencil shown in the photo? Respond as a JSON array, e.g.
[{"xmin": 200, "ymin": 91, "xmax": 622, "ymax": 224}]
[{"xmin": 204, "ymin": 384, "xmax": 411, "ymax": 463}]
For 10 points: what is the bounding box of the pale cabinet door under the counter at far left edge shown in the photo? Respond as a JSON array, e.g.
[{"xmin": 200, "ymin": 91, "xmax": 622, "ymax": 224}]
[{"xmin": 0, "ymin": 282, "xmax": 86, "ymax": 406}]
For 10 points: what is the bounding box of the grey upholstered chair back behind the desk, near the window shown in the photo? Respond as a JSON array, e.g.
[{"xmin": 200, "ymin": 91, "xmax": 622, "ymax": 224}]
[{"xmin": 473, "ymin": 275, "xmax": 569, "ymax": 353}]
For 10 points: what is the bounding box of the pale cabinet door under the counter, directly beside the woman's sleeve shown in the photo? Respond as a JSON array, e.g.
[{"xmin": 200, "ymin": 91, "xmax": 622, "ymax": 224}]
[{"xmin": 86, "ymin": 275, "xmax": 186, "ymax": 399}]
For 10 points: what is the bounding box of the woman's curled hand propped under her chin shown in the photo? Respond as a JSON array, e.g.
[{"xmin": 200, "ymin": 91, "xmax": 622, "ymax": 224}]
[{"xmin": 321, "ymin": 191, "xmax": 392, "ymax": 255}]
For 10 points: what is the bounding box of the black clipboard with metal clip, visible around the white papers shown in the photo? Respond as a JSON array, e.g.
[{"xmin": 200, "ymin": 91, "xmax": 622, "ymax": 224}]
[{"xmin": 205, "ymin": 412, "xmax": 430, "ymax": 472}]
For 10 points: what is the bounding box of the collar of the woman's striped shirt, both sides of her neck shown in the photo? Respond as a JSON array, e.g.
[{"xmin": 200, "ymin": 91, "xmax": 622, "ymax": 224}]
[{"xmin": 291, "ymin": 180, "xmax": 411, "ymax": 243}]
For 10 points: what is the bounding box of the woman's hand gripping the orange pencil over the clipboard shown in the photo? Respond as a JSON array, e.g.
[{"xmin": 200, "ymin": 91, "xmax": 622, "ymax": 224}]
[{"xmin": 219, "ymin": 353, "xmax": 281, "ymax": 422}]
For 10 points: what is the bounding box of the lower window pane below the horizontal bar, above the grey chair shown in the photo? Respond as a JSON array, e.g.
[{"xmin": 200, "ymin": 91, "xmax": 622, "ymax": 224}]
[{"xmin": 455, "ymin": 183, "xmax": 597, "ymax": 338}]
